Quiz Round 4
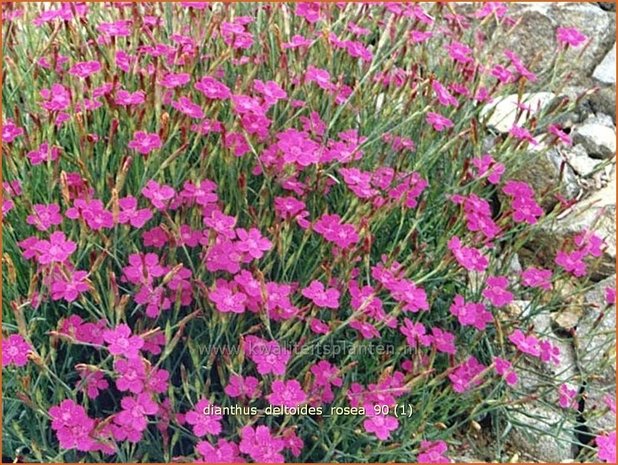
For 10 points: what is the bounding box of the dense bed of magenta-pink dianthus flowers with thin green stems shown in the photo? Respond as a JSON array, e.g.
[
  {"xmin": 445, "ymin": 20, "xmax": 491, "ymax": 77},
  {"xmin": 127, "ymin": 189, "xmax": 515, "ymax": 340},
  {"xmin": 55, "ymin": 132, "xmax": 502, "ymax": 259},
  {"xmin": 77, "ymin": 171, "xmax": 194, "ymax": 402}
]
[{"xmin": 2, "ymin": 2, "xmax": 615, "ymax": 463}]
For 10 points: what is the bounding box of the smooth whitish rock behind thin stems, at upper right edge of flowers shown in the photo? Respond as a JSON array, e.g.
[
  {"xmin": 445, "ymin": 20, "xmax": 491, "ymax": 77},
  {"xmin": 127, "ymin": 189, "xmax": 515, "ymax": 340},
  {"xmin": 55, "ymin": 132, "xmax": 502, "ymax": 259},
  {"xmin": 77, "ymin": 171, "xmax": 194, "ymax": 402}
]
[{"xmin": 481, "ymin": 92, "xmax": 556, "ymax": 133}]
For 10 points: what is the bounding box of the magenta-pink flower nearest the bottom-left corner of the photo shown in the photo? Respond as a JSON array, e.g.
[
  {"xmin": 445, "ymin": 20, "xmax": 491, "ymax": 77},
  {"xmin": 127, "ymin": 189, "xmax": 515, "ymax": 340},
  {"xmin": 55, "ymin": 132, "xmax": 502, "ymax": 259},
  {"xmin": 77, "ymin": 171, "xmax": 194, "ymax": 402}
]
[{"xmin": 49, "ymin": 399, "xmax": 96, "ymax": 452}]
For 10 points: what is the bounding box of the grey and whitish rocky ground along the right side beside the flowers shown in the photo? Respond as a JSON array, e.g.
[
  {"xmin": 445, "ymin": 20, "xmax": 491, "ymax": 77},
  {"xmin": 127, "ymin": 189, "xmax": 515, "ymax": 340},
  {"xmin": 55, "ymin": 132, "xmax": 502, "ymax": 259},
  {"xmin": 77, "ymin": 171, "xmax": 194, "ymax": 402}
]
[{"xmin": 457, "ymin": 2, "xmax": 616, "ymax": 462}]
